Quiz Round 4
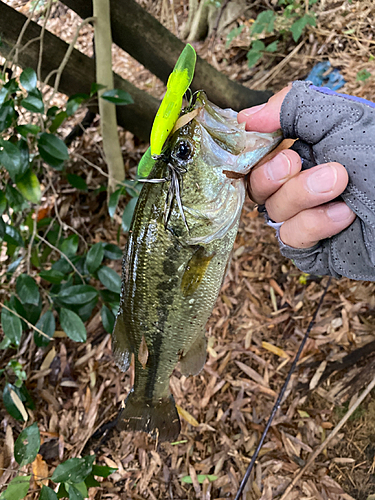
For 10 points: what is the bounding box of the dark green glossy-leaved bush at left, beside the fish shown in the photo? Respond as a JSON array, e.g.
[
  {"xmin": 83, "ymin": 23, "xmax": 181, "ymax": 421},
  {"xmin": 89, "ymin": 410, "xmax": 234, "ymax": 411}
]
[{"xmin": 0, "ymin": 68, "xmax": 139, "ymax": 426}]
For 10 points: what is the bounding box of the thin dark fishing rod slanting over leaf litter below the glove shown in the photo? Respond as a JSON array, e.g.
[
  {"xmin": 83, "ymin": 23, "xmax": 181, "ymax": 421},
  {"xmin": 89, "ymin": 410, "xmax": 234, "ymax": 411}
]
[{"xmin": 234, "ymin": 277, "xmax": 331, "ymax": 500}]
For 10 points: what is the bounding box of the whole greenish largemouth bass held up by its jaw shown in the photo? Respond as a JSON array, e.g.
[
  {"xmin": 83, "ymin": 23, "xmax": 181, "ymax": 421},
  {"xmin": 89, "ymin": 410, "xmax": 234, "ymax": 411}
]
[{"xmin": 112, "ymin": 92, "xmax": 281, "ymax": 440}]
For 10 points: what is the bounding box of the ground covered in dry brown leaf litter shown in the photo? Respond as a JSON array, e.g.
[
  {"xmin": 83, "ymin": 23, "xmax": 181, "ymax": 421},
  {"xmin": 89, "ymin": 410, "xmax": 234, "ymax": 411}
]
[{"xmin": 0, "ymin": 0, "xmax": 375, "ymax": 500}]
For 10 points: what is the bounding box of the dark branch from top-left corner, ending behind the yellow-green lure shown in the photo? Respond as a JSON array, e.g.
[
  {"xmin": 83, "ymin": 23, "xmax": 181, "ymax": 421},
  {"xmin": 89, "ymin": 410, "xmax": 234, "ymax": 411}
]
[{"xmin": 0, "ymin": 0, "xmax": 159, "ymax": 141}]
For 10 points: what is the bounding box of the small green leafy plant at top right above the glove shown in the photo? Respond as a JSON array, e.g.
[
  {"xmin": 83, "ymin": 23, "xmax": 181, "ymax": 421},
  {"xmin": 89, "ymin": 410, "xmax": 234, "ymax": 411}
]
[{"xmin": 227, "ymin": 0, "xmax": 317, "ymax": 68}]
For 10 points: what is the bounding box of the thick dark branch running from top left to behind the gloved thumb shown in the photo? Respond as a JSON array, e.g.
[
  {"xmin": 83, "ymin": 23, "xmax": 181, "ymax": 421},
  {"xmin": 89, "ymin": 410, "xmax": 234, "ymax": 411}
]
[{"xmin": 62, "ymin": 0, "xmax": 272, "ymax": 111}]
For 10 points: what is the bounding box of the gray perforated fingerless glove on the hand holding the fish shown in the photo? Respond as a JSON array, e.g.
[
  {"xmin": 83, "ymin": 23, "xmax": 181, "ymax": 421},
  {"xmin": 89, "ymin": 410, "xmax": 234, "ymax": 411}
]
[{"xmin": 279, "ymin": 81, "xmax": 375, "ymax": 281}]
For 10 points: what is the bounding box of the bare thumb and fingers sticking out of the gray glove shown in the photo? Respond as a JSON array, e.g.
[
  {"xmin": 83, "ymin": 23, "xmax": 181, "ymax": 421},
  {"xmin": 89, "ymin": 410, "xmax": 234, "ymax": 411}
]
[{"xmin": 238, "ymin": 85, "xmax": 355, "ymax": 248}]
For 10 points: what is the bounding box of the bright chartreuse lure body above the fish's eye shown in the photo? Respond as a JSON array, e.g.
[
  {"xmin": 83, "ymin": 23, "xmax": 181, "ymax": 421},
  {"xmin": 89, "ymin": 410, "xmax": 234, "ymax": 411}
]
[{"xmin": 150, "ymin": 44, "xmax": 197, "ymax": 156}]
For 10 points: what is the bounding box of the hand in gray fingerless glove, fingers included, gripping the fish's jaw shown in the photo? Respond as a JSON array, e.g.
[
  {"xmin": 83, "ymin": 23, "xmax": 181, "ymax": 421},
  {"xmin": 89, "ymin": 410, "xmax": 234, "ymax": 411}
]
[{"xmin": 239, "ymin": 81, "xmax": 375, "ymax": 281}]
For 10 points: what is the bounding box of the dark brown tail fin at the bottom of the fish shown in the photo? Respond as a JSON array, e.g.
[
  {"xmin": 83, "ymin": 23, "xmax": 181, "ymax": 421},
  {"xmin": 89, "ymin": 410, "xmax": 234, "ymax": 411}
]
[{"xmin": 117, "ymin": 392, "xmax": 181, "ymax": 441}]
